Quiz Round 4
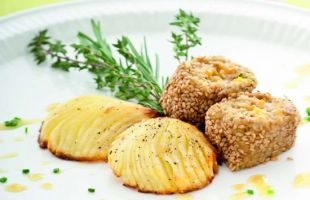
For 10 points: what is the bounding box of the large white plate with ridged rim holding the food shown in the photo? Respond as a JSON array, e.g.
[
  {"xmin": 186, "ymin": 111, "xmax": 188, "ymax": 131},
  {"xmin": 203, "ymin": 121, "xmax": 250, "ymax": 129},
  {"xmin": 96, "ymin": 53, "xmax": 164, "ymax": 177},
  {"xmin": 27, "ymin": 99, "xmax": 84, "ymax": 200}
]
[{"xmin": 0, "ymin": 0, "xmax": 310, "ymax": 200}]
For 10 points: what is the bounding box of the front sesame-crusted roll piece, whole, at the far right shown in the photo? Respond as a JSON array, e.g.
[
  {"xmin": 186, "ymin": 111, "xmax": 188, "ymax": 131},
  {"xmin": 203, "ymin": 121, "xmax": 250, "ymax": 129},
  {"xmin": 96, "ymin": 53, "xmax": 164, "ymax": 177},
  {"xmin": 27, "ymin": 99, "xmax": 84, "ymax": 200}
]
[{"xmin": 205, "ymin": 92, "xmax": 300, "ymax": 171}]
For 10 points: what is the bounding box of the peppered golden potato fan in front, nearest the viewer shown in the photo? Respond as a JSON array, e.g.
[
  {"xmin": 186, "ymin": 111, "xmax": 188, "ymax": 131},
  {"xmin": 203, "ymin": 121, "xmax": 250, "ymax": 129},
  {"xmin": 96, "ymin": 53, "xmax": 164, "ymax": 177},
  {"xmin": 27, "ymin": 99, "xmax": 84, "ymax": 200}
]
[{"xmin": 108, "ymin": 118, "xmax": 218, "ymax": 194}]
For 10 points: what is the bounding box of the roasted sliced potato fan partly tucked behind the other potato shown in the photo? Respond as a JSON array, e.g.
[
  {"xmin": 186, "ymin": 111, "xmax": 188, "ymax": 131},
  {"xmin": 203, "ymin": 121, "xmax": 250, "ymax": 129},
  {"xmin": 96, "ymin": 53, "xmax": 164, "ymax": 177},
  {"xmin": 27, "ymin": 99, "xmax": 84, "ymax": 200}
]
[{"xmin": 39, "ymin": 96, "xmax": 157, "ymax": 161}]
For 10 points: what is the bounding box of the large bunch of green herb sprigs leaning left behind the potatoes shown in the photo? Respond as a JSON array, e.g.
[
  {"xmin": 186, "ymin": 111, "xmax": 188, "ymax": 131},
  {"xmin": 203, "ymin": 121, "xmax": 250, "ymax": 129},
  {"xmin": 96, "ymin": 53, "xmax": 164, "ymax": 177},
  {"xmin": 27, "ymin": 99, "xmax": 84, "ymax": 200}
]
[{"xmin": 28, "ymin": 20, "xmax": 168, "ymax": 113}]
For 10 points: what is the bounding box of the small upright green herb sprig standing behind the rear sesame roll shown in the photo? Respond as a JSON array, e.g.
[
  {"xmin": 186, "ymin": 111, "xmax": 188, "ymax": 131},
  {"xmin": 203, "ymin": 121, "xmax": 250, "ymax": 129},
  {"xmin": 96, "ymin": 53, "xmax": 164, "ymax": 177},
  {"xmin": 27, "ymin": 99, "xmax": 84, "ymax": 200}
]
[{"xmin": 170, "ymin": 9, "xmax": 201, "ymax": 62}]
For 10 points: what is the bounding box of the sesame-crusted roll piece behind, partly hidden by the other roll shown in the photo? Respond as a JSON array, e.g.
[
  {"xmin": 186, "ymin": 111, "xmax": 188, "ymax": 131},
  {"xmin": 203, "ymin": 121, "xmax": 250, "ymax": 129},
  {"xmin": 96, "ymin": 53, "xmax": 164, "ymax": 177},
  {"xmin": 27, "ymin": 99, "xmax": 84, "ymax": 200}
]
[{"xmin": 160, "ymin": 56, "xmax": 257, "ymax": 125}]
